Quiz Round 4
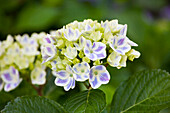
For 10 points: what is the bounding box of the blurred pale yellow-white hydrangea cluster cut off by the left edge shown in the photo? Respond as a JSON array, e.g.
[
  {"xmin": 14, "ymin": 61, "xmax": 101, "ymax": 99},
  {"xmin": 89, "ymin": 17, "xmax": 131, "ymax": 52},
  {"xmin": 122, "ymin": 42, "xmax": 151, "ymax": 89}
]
[{"xmin": 0, "ymin": 33, "xmax": 46, "ymax": 92}]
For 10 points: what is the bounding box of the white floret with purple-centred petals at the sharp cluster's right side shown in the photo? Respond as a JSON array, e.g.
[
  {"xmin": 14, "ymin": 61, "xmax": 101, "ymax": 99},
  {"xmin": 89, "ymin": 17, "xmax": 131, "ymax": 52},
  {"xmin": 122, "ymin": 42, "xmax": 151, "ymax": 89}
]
[{"xmin": 109, "ymin": 35, "xmax": 131, "ymax": 55}]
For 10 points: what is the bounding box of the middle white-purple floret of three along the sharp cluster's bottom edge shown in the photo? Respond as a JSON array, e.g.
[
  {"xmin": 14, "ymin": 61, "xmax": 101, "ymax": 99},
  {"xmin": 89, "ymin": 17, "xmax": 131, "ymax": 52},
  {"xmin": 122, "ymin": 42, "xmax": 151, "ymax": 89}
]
[{"xmin": 73, "ymin": 62, "xmax": 90, "ymax": 81}]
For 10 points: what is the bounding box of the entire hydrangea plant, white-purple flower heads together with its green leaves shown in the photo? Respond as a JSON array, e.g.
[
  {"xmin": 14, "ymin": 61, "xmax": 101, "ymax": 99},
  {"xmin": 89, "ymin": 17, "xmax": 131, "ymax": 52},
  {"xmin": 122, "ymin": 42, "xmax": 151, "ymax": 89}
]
[{"xmin": 0, "ymin": 19, "xmax": 170, "ymax": 113}]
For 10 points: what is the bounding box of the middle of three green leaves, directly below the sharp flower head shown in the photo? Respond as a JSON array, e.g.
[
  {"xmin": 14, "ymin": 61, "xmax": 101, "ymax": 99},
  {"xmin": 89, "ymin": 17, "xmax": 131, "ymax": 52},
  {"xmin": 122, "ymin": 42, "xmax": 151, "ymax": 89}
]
[{"xmin": 64, "ymin": 90, "xmax": 106, "ymax": 113}]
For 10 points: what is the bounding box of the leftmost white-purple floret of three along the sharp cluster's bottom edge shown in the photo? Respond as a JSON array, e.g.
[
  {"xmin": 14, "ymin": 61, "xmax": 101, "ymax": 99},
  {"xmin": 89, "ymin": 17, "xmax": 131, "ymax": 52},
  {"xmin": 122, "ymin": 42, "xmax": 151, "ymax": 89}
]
[{"xmin": 53, "ymin": 65, "xmax": 75, "ymax": 91}]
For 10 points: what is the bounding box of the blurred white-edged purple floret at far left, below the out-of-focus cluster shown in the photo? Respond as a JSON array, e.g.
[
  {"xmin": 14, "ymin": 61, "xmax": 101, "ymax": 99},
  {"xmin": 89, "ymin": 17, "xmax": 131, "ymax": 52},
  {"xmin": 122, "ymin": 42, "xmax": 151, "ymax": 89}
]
[{"xmin": 1, "ymin": 66, "xmax": 22, "ymax": 92}]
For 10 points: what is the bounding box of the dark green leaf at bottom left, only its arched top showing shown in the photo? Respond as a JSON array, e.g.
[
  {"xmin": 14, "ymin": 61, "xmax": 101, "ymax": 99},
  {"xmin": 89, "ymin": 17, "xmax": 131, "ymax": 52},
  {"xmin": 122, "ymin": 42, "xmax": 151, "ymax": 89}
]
[{"xmin": 2, "ymin": 96, "xmax": 66, "ymax": 113}]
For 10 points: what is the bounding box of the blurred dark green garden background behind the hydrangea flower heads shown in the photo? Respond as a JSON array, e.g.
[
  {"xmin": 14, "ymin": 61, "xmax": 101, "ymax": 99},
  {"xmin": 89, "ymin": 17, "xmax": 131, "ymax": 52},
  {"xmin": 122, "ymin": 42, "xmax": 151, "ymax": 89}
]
[{"xmin": 0, "ymin": 0, "xmax": 170, "ymax": 112}]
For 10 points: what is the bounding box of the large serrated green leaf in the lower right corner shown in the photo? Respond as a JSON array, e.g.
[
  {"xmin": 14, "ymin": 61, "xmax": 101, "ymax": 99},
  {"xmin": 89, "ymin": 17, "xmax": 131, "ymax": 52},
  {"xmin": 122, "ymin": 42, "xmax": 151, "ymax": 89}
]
[{"xmin": 111, "ymin": 70, "xmax": 170, "ymax": 113}]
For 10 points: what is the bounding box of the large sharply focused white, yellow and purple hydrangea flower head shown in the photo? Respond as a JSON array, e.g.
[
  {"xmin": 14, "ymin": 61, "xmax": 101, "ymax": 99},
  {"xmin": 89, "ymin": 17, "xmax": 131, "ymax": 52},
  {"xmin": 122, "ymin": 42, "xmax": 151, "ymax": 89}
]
[{"xmin": 41, "ymin": 19, "xmax": 140, "ymax": 91}]
